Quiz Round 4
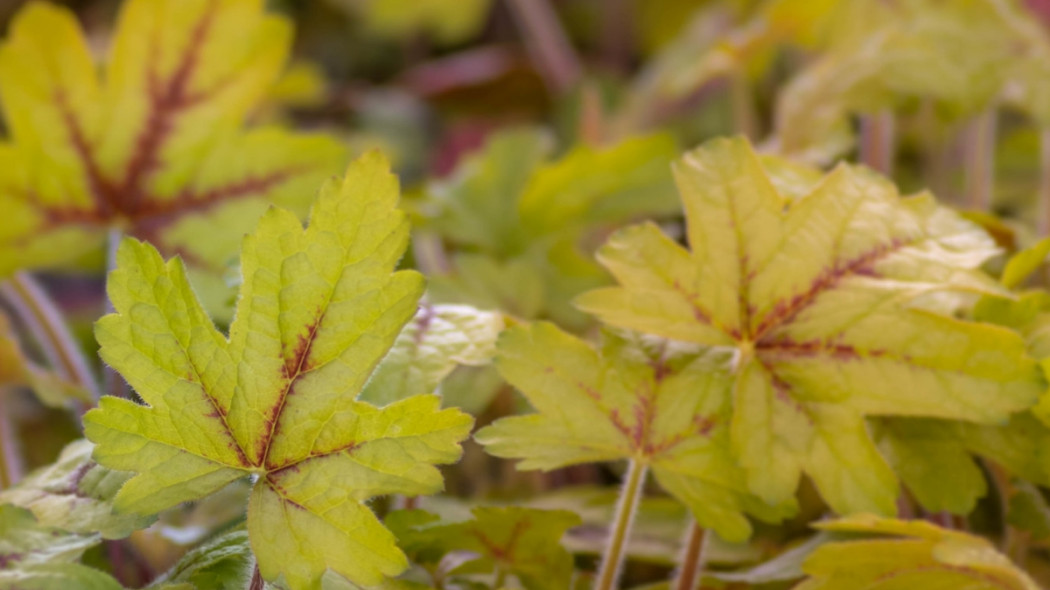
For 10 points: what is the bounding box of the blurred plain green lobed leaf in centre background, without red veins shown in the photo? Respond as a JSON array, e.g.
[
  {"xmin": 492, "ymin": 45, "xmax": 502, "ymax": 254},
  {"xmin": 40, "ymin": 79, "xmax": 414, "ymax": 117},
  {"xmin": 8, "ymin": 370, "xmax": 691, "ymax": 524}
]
[{"xmin": 419, "ymin": 130, "xmax": 675, "ymax": 325}]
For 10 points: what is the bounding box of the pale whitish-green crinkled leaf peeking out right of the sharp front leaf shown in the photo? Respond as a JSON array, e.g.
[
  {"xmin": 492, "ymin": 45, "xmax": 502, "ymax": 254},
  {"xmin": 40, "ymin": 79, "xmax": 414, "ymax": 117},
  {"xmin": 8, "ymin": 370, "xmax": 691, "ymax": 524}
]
[{"xmin": 359, "ymin": 302, "xmax": 503, "ymax": 405}]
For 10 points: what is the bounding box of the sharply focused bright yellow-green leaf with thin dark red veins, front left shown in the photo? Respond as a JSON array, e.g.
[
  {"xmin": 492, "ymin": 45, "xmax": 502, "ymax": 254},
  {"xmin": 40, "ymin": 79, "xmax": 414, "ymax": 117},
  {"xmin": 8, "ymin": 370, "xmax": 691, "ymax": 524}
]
[{"xmin": 84, "ymin": 152, "xmax": 471, "ymax": 590}]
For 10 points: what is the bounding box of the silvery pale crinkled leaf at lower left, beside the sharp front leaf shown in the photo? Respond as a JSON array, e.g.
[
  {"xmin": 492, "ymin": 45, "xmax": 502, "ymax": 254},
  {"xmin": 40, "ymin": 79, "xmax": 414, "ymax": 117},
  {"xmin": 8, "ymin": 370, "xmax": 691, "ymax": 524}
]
[{"xmin": 0, "ymin": 440, "xmax": 153, "ymax": 539}]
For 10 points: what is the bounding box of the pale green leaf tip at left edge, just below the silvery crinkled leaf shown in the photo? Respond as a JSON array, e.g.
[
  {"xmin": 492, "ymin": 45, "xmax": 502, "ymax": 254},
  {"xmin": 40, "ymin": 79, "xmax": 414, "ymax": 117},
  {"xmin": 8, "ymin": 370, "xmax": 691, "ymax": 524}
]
[{"xmin": 0, "ymin": 504, "xmax": 100, "ymax": 571}]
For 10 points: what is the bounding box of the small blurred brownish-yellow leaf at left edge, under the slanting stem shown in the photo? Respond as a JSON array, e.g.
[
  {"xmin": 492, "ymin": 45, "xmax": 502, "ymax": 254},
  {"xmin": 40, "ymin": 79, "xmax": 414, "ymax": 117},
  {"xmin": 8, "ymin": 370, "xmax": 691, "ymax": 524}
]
[{"xmin": 0, "ymin": 312, "xmax": 93, "ymax": 406}]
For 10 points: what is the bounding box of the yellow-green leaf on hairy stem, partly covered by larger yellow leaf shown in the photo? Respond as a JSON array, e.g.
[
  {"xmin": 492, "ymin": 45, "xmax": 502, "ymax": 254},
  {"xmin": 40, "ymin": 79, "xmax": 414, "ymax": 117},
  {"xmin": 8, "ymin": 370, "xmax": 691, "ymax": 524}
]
[{"xmin": 476, "ymin": 323, "xmax": 793, "ymax": 541}]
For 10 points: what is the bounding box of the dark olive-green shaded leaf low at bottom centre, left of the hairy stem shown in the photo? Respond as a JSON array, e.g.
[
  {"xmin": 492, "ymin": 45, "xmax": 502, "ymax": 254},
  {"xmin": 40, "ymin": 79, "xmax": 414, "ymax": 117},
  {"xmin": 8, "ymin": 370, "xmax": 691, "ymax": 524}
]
[{"xmin": 386, "ymin": 506, "xmax": 581, "ymax": 590}]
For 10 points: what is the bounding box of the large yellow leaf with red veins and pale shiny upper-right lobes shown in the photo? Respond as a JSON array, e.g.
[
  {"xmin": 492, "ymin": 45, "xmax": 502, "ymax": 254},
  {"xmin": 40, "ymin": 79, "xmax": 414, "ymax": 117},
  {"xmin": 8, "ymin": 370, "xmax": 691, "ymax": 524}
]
[{"xmin": 579, "ymin": 139, "xmax": 1045, "ymax": 514}]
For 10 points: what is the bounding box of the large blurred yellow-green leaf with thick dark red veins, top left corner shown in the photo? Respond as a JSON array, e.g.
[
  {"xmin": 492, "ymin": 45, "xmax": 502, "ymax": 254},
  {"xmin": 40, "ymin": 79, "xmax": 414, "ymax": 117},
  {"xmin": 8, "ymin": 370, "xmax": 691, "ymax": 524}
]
[{"xmin": 0, "ymin": 0, "xmax": 343, "ymax": 287}]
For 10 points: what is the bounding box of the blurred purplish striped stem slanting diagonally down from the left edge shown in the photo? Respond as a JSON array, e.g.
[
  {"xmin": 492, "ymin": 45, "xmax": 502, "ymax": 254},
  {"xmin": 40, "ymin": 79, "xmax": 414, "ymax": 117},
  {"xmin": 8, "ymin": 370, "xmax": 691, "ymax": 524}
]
[{"xmin": 0, "ymin": 272, "xmax": 99, "ymax": 399}]
